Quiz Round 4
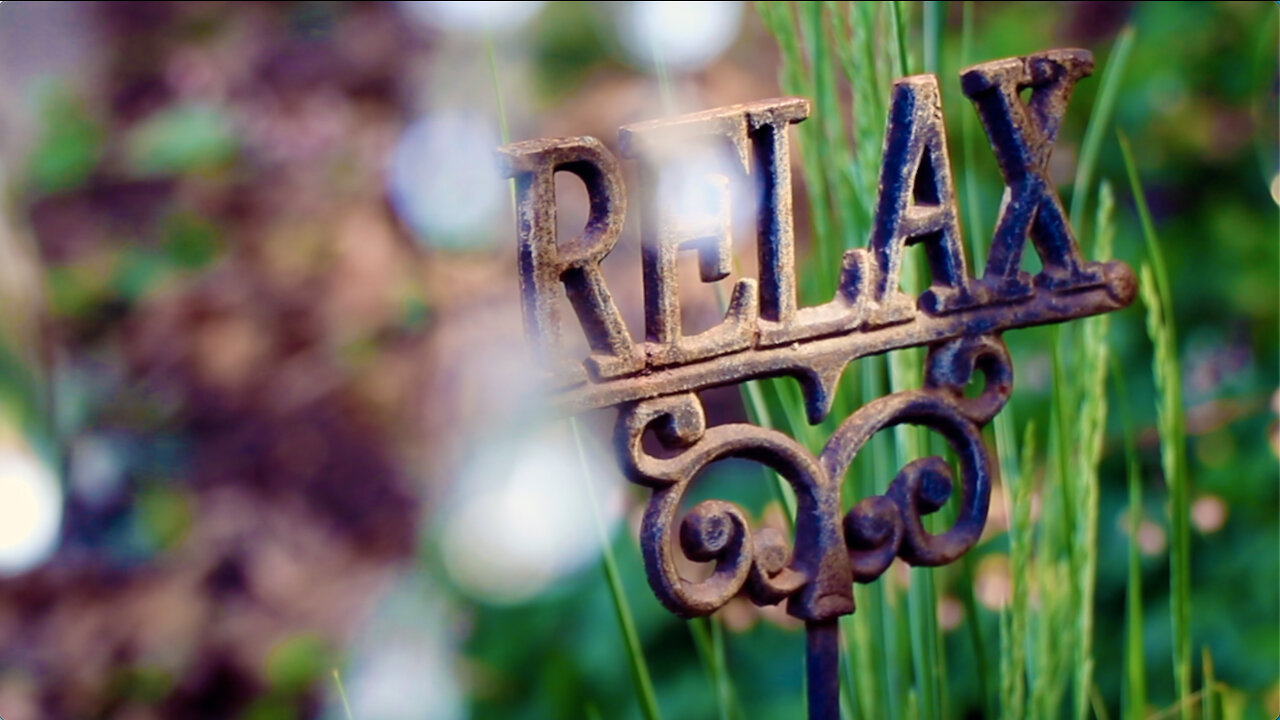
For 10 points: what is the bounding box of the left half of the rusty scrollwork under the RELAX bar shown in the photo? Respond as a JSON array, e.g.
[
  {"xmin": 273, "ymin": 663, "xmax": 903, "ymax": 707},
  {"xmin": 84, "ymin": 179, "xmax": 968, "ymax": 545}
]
[{"xmin": 617, "ymin": 395, "xmax": 852, "ymax": 616}]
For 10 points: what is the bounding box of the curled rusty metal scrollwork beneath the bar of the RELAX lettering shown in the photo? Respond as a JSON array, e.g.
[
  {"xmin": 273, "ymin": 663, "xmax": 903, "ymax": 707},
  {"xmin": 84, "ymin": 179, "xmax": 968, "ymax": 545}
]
[{"xmin": 616, "ymin": 336, "xmax": 1012, "ymax": 620}]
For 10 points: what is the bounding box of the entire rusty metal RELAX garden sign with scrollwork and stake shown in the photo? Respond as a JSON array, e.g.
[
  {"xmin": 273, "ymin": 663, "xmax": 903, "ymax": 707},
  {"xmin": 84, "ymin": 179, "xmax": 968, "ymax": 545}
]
[{"xmin": 499, "ymin": 50, "xmax": 1134, "ymax": 720}]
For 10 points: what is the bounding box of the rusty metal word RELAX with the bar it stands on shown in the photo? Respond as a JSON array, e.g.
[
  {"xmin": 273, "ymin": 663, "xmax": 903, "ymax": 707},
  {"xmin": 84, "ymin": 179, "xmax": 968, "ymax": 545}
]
[{"xmin": 499, "ymin": 50, "xmax": 1134, "ymax": 421}]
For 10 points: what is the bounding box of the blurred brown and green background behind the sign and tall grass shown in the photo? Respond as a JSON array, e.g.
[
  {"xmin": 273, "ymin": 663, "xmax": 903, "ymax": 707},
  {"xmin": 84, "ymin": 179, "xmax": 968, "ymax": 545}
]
[{"xmin": 0, "ymin": 0, "xmax": 1280, "ymax": 720}]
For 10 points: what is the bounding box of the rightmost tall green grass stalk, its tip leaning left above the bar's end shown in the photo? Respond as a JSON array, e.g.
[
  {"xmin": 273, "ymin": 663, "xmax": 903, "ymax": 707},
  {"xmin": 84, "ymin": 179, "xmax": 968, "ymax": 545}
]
[{"xmin": 1120, "ymin": 135, "xmax": 1192, "ymax": 720}]
